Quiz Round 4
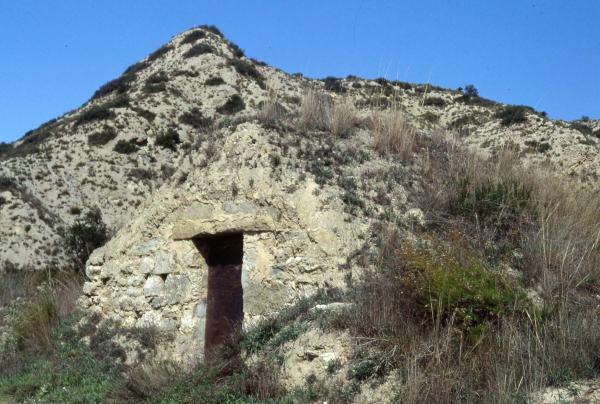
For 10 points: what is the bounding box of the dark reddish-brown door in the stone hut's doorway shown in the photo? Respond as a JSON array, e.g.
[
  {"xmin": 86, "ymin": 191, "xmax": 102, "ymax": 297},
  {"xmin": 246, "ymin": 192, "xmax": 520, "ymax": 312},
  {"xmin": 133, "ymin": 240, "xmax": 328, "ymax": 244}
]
[{"xmin": 194, "ymin": 234, "xmax": 244, "ymax": 355}]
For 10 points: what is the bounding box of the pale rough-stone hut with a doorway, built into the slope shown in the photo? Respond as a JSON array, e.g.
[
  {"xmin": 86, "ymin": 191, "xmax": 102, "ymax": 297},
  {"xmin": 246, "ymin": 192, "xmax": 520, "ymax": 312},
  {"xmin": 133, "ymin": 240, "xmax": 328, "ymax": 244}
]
[{"xmin": 81, "ymin": 123, "xmax": 368, "ymax": 362}]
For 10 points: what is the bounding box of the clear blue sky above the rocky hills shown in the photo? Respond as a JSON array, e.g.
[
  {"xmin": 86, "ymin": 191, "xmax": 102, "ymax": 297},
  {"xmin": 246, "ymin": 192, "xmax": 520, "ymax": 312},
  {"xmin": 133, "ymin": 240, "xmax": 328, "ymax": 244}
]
[{"xmin": 0, "ymin": 0, "xmax": 600, "ymax": 141}]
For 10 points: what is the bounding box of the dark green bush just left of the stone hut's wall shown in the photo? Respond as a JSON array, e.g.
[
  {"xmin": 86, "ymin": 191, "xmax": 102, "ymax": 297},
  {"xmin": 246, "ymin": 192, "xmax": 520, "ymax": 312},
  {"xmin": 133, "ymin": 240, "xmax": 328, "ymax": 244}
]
[{"xmin": 65, "ymin": 208, "xmax": 108, "ymax": 269}]
